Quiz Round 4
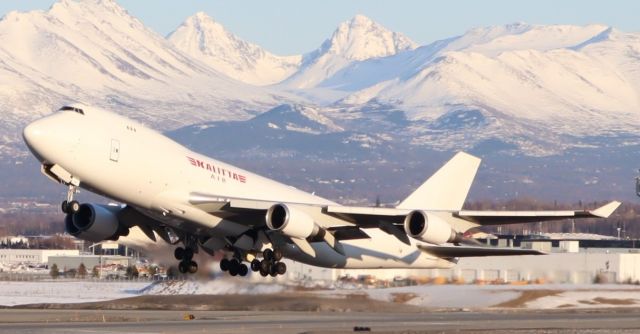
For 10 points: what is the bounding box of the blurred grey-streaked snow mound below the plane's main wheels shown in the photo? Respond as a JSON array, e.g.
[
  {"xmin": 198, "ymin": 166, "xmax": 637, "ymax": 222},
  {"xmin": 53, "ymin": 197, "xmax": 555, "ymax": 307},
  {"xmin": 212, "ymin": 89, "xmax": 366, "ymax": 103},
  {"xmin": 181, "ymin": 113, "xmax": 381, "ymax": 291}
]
[{"xmin": 141, "ymin": 278, "xmax": 287, "ymax": 295}]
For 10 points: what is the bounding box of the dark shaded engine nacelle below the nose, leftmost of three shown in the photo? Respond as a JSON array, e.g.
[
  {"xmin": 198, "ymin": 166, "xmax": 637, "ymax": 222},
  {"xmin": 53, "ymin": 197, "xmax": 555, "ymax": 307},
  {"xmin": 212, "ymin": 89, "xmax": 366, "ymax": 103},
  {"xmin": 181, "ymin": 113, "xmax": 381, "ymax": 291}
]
[{"xmin": 65, "ymin": 203, "xmax": 121, "ymax": 242}]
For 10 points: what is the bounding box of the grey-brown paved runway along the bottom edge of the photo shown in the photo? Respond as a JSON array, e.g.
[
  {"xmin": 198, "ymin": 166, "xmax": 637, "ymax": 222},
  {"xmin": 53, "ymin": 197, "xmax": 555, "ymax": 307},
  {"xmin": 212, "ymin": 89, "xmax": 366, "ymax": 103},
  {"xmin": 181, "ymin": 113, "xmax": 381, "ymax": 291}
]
[{"xmin": 0, "ymin": 309, "xmax": 640, "ymax": 334}]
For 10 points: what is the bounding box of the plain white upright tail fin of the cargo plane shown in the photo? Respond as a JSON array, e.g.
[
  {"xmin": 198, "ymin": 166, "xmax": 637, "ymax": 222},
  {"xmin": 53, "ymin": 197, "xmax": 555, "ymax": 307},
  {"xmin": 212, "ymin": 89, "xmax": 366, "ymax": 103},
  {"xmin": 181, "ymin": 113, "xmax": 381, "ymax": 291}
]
[{"xmin": 397, "ymin": 152, "xmax": 480, "ymax": 210}]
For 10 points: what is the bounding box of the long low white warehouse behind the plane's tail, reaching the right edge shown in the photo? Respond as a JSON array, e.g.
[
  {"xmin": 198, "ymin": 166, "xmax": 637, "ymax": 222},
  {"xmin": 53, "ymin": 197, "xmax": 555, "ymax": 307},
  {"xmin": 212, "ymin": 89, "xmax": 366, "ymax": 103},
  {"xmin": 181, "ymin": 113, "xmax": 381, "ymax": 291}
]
[{"xmin": 284, "ymin": 249, "xmax": 640, "ymax": 284}]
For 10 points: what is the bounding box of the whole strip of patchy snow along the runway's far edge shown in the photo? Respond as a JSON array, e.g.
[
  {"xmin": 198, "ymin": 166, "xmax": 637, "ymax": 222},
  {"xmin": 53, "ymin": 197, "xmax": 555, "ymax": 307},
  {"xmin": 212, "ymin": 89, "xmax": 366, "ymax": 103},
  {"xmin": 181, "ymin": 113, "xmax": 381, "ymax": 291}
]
[{"xmin": 0, "ymin": 278, "xmax": 640, "ymax": 309}]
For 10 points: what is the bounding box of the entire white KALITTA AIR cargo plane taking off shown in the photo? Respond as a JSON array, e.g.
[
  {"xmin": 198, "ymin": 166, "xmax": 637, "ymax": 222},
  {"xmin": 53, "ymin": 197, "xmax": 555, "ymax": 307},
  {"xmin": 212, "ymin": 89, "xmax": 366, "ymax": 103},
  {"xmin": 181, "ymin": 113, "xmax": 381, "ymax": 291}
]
[{"xmin": 23, "ymin": 104, "xmax": 620, "ymax": 276}]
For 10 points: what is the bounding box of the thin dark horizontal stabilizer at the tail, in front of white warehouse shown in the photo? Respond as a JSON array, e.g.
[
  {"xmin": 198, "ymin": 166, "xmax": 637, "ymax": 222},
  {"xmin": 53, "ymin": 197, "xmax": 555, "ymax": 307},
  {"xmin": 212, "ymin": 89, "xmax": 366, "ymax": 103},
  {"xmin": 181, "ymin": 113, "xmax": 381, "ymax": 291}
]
[{"xmin": 418, "ymin": 245, "xmax": 546, "ymax": 258}]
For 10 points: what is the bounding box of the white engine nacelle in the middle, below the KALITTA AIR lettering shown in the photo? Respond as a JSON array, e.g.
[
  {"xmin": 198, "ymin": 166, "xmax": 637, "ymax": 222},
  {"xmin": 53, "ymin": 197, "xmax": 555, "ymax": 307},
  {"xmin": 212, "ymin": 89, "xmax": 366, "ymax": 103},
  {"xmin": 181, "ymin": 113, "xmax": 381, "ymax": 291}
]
[{"xmin": 265, "ymin": 204, "xmax": 319, "ymax": 239}]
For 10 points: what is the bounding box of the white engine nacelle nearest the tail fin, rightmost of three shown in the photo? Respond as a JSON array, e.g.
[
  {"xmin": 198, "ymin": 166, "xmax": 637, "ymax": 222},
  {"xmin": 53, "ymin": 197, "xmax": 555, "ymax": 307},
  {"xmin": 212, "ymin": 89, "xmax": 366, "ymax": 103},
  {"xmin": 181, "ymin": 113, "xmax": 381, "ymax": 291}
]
[{"xmin": 404, "ymin": 211, "xmax": 456, "ymax": 245}]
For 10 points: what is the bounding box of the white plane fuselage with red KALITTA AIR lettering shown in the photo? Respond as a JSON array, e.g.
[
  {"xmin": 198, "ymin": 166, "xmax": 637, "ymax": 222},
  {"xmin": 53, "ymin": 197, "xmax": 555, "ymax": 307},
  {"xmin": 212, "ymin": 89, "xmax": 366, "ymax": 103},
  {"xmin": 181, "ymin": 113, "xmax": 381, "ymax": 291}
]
[{"xmin": 24, "ymin": 106, "xmax": 454, "ymax": 268}]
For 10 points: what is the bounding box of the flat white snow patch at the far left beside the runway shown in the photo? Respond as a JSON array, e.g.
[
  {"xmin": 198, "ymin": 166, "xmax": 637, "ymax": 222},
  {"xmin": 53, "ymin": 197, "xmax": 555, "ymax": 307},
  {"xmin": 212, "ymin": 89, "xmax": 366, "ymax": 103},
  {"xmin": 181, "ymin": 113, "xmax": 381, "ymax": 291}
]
[{"xmin": 0, "ymin": 280, "xmax": 149, "ymax": 306}]
